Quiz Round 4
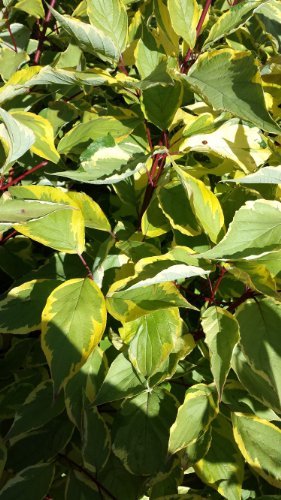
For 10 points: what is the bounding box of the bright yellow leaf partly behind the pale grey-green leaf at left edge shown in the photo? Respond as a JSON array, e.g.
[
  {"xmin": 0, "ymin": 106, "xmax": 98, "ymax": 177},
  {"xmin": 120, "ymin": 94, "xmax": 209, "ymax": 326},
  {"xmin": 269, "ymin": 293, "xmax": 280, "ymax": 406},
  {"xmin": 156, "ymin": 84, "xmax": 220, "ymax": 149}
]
[{"xmin": 11, "ymin": 111, "xmax": 60, "ymax": 163}]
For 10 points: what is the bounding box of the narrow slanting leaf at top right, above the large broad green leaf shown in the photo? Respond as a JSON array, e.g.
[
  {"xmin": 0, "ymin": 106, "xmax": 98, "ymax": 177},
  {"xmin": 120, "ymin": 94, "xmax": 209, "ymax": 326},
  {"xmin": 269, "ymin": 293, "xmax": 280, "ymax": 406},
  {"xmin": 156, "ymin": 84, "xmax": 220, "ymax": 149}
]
[{"xmin": 204, "ymin": 0, "xmax": 263, "ymax": 48}]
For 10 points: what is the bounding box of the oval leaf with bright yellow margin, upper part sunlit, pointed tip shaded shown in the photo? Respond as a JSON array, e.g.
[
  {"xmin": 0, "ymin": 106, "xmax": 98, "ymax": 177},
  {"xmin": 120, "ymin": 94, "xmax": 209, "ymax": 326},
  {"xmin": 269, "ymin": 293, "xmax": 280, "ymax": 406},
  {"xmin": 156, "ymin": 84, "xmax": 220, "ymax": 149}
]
[{"xmin": 41, "ymin": 278, "xmax": 106, "ymax": 393}]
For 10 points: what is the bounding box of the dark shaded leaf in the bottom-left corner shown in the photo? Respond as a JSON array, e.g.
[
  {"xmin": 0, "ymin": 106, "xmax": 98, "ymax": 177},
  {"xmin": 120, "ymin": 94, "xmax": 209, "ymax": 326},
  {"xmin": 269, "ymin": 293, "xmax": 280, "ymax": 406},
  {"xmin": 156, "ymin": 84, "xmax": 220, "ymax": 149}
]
[{"xmin": 0, "ymin": 464, "xmax": 55, "ymax": 500}]
